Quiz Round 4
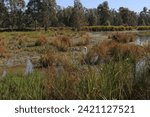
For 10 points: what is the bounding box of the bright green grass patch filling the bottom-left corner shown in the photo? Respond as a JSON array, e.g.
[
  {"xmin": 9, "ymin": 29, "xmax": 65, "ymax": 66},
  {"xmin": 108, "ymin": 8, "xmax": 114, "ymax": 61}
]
[{"xmin": 0, "ymin": 72, "xmax": 45, "ymax": 100}]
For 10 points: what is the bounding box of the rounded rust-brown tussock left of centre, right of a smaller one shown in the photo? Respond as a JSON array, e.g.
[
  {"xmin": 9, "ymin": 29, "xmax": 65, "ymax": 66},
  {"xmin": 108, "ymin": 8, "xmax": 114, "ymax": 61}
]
[{"xmin": 51, "ymin": 35, "xmax": 72, "ymax": 51}]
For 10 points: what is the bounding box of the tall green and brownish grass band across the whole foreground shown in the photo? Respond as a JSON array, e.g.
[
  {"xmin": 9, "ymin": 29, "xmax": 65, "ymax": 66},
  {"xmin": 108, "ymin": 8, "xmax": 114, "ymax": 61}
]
[{"xmin": 0, "ymin": 60, "xmax": 150, "ymax": 100}]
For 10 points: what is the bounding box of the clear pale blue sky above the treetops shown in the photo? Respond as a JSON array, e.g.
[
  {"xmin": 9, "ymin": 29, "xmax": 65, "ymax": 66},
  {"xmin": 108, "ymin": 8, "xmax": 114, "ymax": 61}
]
[{"xmin": 25, "ymin": 0, "xmax": 150, "ymax": 12}]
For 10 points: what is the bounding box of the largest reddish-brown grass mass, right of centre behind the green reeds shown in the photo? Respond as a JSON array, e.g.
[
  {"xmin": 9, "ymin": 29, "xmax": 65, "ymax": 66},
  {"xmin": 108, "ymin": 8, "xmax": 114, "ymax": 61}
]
[{"xmin": 86, "ymin": 40, "xmax": 146, "ymax": 61}]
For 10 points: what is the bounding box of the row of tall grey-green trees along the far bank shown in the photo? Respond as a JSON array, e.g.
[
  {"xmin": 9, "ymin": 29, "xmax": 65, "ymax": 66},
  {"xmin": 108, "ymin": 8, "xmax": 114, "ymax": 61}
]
[{"xmin": 0, "ymin": 0, "xmax": 150, "ymax": 30}]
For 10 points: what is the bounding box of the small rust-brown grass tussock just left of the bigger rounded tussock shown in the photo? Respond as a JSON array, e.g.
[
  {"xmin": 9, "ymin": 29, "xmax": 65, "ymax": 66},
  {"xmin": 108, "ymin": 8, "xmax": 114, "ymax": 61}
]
[{"xmin": 35, "ymin": 34, "xmax": 48, "ymax": 46}]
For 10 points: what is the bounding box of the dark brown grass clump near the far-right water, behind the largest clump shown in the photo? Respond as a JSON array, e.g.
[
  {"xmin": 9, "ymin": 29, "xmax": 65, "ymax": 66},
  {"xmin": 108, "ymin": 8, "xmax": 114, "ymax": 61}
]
[{"xmin": 108, "ymin": 33, "xmax": 135, "ymax": 43}]
